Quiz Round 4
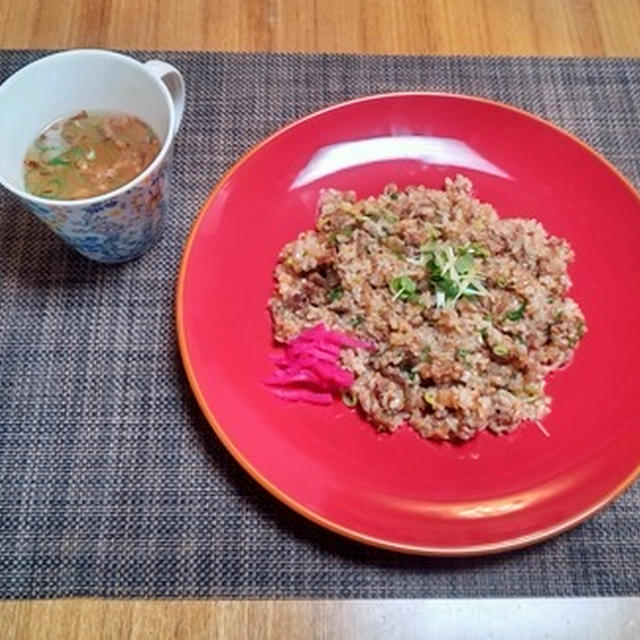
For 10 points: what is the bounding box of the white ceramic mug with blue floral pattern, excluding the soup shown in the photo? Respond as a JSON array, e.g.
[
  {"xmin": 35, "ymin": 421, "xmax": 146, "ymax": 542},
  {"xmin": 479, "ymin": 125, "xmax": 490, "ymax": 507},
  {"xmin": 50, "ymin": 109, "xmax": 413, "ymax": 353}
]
[{"xmin": 0, "ymin": 49, "xmax": 184, "ymax": 262}]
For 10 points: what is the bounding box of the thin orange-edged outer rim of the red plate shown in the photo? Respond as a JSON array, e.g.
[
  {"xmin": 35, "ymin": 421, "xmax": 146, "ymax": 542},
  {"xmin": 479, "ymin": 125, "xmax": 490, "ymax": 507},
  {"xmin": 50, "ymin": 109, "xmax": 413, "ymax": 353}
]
[{"xmin": 176, "ymin": 91, "xmax": 640, "ymax": 556}]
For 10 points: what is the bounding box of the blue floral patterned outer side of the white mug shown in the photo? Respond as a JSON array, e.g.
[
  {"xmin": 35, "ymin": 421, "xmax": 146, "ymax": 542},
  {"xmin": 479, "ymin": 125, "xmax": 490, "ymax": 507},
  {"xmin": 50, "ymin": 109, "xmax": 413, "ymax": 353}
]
[{"xmin": 26, "ymin": 157, "xmax": 171, "ymax": 262}]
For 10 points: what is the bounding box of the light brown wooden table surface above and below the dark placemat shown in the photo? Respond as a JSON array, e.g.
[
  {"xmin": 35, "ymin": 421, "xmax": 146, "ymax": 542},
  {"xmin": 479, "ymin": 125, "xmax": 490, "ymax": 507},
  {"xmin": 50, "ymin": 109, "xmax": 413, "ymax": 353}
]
[{"xmin": 0, "ymin": 0, "xmax": 640, "ymax": 640}]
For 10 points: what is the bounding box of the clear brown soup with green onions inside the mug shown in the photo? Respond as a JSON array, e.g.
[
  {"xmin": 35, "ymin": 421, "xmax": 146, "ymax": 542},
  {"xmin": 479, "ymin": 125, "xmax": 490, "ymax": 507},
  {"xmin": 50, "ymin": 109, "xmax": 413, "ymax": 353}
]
[{"xmin": 24, "ymin": 111, "xmax": 162, "ymax": 200}]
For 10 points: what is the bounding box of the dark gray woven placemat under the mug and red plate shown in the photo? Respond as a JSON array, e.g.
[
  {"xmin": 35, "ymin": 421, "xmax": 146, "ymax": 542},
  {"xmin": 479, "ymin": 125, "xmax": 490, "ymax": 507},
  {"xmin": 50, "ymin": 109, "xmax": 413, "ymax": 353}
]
[{"xmin": 0, "ymin": 51, "xmax": 640, "ymax": 598}]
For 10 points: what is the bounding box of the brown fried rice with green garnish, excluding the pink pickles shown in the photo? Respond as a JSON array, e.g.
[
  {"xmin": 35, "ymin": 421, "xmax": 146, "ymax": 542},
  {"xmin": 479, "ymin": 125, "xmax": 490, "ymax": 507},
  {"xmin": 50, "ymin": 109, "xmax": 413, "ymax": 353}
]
[{"xmin": 270, "ymin": 176, "xmax": 585, "ymax": 441}]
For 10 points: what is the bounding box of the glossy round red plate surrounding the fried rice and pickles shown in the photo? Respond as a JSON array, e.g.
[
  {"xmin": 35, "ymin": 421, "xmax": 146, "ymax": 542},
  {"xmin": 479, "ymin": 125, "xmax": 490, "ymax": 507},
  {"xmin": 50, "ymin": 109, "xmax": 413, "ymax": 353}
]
[{"xmin": 177, "ymin": 94, "xmax": 640, "ymax": 555}]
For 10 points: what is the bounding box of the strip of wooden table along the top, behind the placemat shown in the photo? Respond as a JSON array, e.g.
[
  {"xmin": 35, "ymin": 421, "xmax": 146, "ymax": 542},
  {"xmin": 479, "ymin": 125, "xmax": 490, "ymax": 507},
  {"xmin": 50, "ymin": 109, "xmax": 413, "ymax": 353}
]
[{"xmin": 0, "ymin": 0, "xmax": 640, "ymax": 56}]
